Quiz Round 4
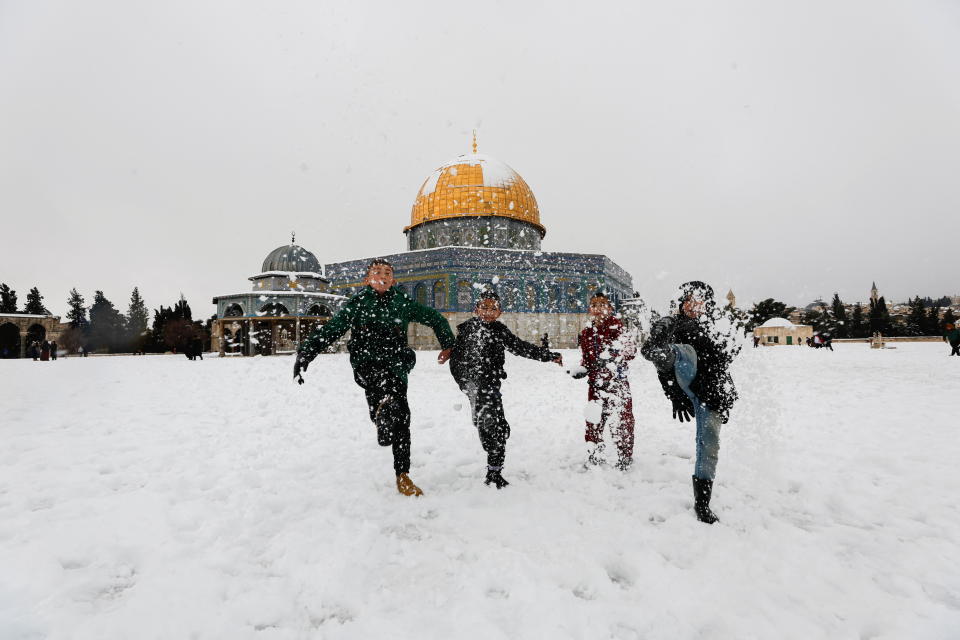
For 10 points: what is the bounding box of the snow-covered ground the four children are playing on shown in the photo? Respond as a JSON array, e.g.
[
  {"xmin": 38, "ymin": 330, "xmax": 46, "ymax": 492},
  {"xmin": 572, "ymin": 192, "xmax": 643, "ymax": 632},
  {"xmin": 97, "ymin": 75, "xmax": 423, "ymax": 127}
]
[{"xmin": 0, "ymin": 344, "xmax": 960, "ymax": 640}]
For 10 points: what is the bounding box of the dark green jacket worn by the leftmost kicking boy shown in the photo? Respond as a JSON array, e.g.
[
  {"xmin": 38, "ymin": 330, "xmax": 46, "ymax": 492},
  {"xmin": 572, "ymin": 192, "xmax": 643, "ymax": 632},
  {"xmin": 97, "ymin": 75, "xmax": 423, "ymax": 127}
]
[{"xmin": 297, "ymin": 286, "xmax": 455, "ymax": 380}]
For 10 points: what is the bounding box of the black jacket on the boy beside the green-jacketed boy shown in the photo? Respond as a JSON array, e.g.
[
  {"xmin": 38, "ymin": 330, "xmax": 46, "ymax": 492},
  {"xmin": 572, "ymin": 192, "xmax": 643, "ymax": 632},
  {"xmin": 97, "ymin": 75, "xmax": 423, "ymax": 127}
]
[{"xmin": 450, "ymin": 316, "xmax": 560, "ymax": 386}]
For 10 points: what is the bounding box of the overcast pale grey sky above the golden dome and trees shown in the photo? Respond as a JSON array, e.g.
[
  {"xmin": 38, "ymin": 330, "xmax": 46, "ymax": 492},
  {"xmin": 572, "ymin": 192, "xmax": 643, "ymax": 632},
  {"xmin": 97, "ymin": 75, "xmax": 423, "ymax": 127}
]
[{"xmin": 0, "ymin": 0, "xmax": 960, "ymax": 316}]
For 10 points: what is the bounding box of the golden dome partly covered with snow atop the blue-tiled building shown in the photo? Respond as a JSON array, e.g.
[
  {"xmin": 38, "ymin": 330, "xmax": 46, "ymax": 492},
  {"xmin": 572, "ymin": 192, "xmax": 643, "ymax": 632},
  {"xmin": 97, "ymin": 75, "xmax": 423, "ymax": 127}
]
[{"xmin": 404, "ymin": 153, "xmax": 546, "ymax": 237}]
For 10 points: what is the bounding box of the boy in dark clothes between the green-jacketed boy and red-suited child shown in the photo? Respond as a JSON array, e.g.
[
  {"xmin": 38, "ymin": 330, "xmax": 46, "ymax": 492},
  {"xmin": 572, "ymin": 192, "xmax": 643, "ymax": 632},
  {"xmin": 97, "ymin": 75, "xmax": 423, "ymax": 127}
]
[{"xmin": 450, "ymin": 291, "xmax": 563, "ymax": 489}]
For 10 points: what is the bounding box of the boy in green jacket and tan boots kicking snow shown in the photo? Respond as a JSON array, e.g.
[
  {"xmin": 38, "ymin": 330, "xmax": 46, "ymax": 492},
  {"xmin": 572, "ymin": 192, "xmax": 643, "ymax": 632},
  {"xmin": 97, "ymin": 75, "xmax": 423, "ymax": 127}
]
[{"xmin": 293, "ymin": 258, "xmax": 454, "ymax": 496}]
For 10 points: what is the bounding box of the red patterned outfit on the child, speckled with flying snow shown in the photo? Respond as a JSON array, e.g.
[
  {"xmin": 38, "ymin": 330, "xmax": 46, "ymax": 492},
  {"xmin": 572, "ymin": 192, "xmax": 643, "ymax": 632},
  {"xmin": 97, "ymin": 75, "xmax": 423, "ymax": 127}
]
[{"xmin": 580, "ymin": 316, "xmax": 636, "ymax": 462}]
